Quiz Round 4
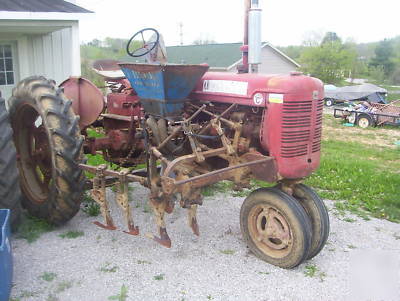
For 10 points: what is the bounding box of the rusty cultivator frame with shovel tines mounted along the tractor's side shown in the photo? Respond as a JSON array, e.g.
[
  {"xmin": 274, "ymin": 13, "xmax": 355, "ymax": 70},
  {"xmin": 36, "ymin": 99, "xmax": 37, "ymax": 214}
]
[{"xmin": 79, "ymin": 99, "xmax": 277, "ymax": 247}]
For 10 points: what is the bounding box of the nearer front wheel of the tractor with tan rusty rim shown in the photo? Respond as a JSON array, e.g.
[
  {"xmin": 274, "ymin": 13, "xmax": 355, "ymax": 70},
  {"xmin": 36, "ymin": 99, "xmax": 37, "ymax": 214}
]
[{"xmin": 240, "ymin": 188, "xmax": 312, "ymax": 269}]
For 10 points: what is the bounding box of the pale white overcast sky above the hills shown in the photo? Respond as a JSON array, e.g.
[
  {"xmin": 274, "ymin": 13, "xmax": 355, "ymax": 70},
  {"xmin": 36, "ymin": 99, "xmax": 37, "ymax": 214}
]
[{"xmin": 76, "ymin": 0, "xmax": 400, "ymax": 46}]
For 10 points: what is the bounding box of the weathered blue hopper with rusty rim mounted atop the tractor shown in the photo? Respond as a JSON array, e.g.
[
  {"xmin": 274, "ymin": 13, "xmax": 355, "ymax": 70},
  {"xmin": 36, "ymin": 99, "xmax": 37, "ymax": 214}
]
[{"xmin": 119, "ymin": 63, "xmax": 209, "ymax": 117}]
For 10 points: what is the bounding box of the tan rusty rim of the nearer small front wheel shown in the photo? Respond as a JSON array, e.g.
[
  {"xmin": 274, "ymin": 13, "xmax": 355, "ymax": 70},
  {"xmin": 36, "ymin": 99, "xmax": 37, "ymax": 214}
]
[{"xmin": 248, "ymin": 204, "xmax": 293, "ymax": 258}]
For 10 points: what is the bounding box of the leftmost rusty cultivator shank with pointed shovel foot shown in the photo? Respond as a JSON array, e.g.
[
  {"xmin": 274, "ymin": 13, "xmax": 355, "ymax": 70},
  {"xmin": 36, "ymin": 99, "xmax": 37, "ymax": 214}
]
[{"xmin": 91, "ymin": 164, "xmax": 116, "ymax": 230}]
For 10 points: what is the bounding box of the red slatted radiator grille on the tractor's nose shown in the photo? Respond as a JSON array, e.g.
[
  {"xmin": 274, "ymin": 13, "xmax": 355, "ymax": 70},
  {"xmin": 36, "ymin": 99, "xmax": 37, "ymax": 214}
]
[{"xmin": 281, "ymin": 100, "xmax": 323, "ymax": 158}]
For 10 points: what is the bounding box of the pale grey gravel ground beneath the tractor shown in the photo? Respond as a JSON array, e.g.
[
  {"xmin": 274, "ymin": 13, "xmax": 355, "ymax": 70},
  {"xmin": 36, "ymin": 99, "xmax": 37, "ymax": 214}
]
[{"xmin": 12, "ymin": 186, "xmax": 400, "ymax": 301}]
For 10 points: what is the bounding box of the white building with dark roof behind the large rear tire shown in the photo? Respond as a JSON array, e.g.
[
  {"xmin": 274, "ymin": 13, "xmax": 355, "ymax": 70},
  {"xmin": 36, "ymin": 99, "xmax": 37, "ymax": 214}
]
[{"xmin": 0, "ymin": 0, "xmax": 91, "ymax": 98}]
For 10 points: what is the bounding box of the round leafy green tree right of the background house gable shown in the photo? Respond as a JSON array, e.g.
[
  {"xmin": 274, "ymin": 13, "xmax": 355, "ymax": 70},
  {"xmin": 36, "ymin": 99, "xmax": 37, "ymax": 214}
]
[{"xmin": 300, "ymin": 40, "xmax": 357, "ymax": 84}]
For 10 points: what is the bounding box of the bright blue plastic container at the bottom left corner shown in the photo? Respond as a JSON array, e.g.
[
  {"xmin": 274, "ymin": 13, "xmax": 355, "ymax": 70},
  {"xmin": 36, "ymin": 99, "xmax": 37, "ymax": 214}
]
[{"xmin": 0, "ymin": 209, "xmax": 13, "ymax": 301}]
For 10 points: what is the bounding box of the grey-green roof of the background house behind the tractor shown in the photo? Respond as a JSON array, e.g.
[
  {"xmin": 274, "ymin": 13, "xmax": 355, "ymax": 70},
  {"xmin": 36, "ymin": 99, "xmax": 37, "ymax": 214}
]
[{"xmin": 163, "ymin": 43, "xmax": 300, "ymax": 69}]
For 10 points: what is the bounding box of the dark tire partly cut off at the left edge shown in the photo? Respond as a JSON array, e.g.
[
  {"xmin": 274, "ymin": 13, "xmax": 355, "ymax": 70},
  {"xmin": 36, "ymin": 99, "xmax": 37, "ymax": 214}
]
[{"xmin": 0, "ymin": 98, "xmax": 21, "ymax": 230}]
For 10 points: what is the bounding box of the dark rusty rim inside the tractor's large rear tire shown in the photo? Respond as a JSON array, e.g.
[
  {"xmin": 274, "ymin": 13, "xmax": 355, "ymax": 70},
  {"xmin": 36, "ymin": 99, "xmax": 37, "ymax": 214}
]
[{"xmin": 14, "ymin": 103, "xmax": 53, "ymax": 203}]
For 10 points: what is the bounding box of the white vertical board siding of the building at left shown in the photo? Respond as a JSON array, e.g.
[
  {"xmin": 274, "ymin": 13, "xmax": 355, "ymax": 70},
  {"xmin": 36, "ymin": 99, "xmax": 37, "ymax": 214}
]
[{"xmin": 0, "ymin": 20, "xmax": 81, "ymax": 98}]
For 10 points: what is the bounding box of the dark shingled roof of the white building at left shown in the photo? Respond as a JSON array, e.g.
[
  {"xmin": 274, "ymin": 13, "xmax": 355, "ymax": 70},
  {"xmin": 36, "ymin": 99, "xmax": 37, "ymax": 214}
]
[{"xmin": 0, "ymin": 0, "xmax": 92, "ymax": 13}]
